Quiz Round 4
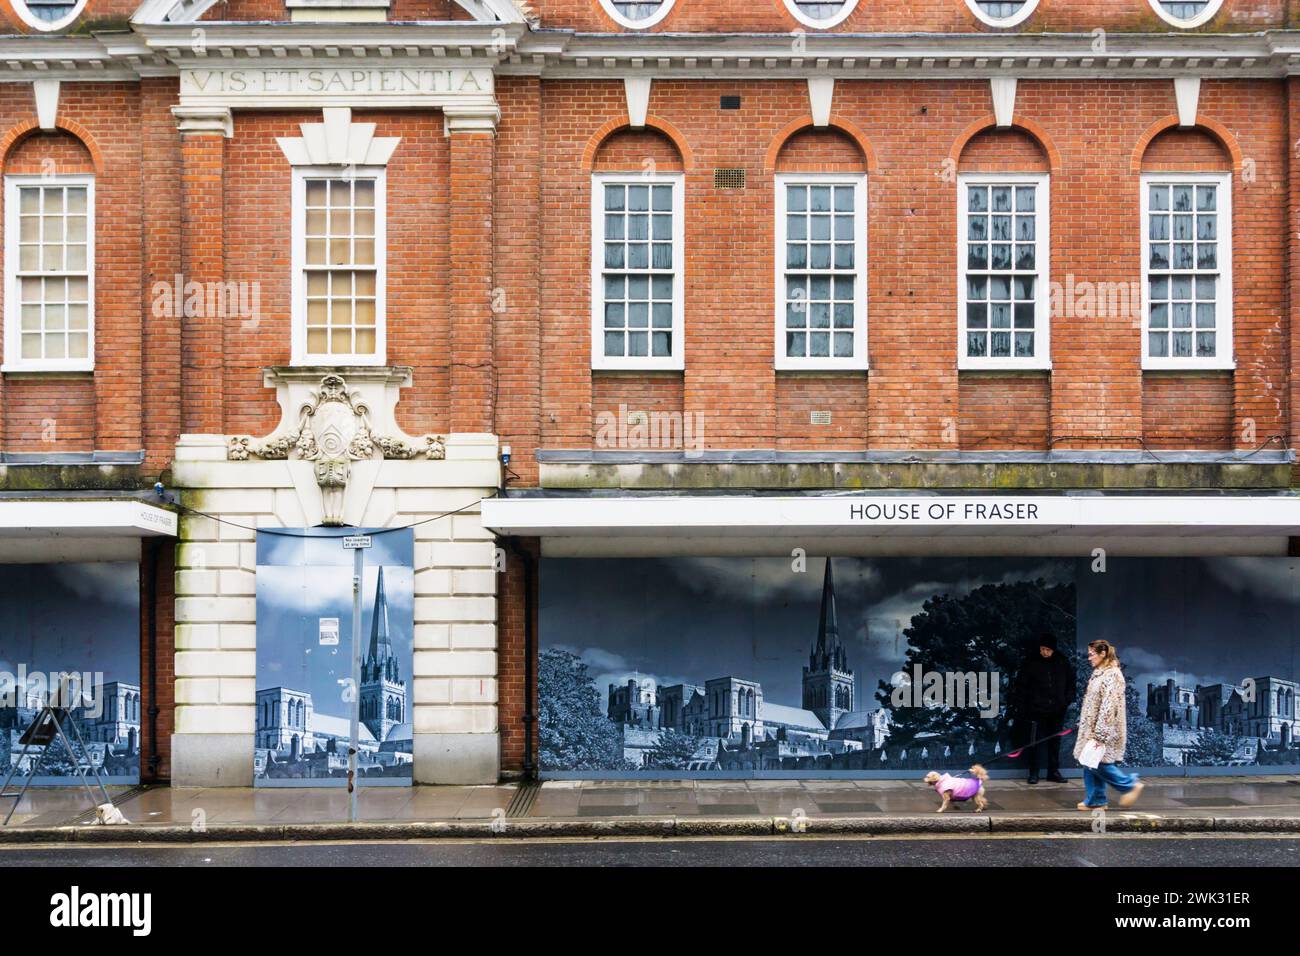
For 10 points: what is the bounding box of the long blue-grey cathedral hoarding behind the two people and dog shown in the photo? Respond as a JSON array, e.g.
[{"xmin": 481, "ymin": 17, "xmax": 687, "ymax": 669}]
[{"xmin": 538, "ymin": 557, "xmax": 1300, "ymax": 779}]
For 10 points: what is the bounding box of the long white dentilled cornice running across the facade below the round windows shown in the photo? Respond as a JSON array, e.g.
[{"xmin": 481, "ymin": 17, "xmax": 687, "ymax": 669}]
[{"xmin": 10, "ymin": 26, "xmax": 1300, "ymax": 82}]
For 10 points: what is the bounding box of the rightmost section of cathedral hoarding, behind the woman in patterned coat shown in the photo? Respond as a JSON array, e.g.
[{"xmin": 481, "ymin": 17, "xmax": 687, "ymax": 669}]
[{"xmin": 1076, "ymin": 557, "xmax": 1300, "ymax": 774}]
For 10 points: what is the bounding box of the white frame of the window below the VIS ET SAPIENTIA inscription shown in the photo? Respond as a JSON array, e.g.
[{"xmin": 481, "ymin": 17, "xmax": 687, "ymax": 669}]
[{"xmin": 290, "ymin": 166, "xmax": 389, "ymax": 365}]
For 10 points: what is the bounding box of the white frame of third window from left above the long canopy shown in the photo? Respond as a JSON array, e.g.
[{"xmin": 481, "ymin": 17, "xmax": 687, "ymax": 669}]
[{"xmin": 957, "ymin": 173, "xmax": 1052, "ymax": 371}]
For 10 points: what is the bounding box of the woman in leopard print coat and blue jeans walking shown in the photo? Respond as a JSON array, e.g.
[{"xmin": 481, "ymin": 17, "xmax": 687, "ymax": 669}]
[{"xmin": 1074, "ymin": 641, "xmax": 1145, "ymax": 810}]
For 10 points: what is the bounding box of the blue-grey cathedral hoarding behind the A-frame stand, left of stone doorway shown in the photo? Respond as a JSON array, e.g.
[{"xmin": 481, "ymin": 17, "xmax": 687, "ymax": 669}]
[{"xmin": 0, "ymin": 562, "xmax": 140, "ymax": 787}]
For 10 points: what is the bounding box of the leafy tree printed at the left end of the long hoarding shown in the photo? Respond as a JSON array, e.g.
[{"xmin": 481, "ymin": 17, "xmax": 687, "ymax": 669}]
[{"xmin": 537, "ymin": 648, "xmax": 629, "ymax": 770}]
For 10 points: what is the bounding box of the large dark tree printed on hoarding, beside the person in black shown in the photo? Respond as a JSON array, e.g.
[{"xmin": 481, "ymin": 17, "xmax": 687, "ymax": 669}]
[{"xmin": 876, "ymin": 579, "xmax": 1075, "ymax": 749}]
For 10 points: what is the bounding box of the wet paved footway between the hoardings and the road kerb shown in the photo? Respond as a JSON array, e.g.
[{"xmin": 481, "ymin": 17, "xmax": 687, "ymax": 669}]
[{"xmin": 5, "ymin": 777, "xmax": 1300, "ymax": 829}]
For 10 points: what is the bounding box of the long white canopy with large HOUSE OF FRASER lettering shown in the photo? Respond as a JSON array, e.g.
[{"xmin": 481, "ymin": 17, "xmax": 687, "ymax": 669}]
[{"xmin": 482, "ymin": 492, "xmax": 1300, "ymax": 557}]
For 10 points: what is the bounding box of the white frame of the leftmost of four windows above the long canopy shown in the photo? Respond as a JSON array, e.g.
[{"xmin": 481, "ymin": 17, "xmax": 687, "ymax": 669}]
[{"xmin": 592, "ymin": 173, "xmax": 686, "ymax": 371}]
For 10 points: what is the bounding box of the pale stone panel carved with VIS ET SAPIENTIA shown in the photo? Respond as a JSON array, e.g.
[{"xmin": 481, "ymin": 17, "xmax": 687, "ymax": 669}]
[{"xmin": 181, "ymin": 66, "xmax": 494, "ymax": 108}]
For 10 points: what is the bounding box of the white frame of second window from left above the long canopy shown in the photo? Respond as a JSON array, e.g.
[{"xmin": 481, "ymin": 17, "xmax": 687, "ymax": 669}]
[{"xmin": 772, "ymin": 173, "xmax": 868, "ymax": 371}]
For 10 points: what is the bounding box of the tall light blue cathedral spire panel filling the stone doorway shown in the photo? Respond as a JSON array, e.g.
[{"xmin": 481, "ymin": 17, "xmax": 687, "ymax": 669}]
[{"xmin": 254, "ymin": 528, "xmax": 415, "ymax": 787}]
